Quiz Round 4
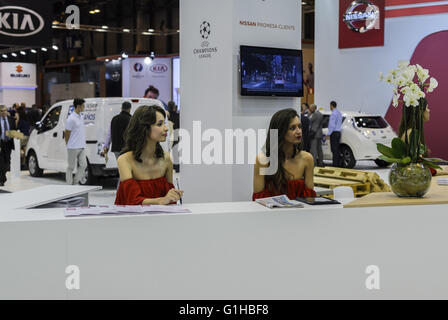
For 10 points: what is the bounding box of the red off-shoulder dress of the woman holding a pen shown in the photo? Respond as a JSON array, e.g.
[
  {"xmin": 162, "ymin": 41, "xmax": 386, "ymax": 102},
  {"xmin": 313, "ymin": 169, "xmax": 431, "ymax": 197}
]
[{"xmin": 115, "ymin": 177, "xmax": 174, "ymax": 206}]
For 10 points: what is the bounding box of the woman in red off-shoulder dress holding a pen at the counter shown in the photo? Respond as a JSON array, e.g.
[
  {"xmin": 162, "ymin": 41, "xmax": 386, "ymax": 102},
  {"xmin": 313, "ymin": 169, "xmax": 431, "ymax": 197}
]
[{"xmin": 115, "ymin": 106, "xmax": 183, "ymax": 205}]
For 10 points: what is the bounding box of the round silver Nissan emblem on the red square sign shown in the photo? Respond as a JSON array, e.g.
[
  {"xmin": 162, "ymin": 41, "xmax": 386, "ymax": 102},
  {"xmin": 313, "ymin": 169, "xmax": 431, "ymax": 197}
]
[{"xmin": 344, "ymin": 0, "xmax": 380, "ymax": 33}]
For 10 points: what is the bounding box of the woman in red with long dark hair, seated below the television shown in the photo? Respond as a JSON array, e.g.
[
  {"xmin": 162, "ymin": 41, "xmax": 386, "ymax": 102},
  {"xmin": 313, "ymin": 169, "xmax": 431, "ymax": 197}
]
[{"xmin": 252, "ymin": 109, "xmax": 316, "ymax": 200}]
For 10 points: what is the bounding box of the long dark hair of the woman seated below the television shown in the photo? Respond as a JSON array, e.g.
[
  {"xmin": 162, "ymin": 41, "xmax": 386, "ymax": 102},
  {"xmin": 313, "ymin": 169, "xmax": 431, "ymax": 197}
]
[{"xmin": 265, "ymin": 109, "xmax": 303, "ymax": 193}]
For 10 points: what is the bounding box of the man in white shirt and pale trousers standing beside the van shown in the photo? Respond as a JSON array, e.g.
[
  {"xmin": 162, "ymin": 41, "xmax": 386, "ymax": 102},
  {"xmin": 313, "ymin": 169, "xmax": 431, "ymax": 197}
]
[{"xmin": 65, "ymin": 98, "xmax": 87, "ymax": 184}]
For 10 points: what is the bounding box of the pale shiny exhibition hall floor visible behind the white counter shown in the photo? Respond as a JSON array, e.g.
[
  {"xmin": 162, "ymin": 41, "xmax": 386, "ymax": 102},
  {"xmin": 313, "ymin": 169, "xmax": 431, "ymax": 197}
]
[{"xmin": 0, "ymin": 161, "xmax": 390, "ymax": 205}]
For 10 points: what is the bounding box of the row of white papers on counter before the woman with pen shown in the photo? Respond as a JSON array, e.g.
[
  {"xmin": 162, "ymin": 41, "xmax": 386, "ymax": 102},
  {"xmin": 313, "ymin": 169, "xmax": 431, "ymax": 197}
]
[{"xmin": 64, "ymin": 205, "xmax": 191, "ymax": 217}]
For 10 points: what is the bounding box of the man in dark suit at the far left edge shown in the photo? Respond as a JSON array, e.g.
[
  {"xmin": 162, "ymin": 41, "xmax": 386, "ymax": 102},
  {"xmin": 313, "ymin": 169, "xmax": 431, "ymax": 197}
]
[{"xmin": 0, "ymin": 105, "xmax": 16, "ymax": 187}]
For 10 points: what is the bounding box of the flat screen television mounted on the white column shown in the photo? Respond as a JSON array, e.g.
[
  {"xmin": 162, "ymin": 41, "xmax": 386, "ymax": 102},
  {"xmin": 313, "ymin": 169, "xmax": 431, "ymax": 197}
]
[{"xmin": 240, "ymin": 46, "xmax": 303, "ymax": 97}]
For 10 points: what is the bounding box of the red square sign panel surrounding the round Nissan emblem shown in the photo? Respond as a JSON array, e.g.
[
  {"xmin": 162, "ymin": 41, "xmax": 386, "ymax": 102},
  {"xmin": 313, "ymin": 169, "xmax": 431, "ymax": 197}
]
[{"xmin": 339, "ymin": 0, "xmax": 385, "ymax": 49}]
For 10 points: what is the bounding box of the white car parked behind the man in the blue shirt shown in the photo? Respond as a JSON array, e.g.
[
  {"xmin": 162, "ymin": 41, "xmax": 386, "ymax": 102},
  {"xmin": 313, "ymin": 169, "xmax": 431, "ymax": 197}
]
[{"xmin": 321, "ymin": 111, "xmax": 397, "ymax": 168}]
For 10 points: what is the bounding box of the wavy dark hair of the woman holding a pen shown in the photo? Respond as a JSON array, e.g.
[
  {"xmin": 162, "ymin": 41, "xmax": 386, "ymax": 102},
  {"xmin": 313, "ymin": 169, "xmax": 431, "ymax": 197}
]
[{"xmin": 121, "ymin": 106, "xmax": 166, "ymax": 162}]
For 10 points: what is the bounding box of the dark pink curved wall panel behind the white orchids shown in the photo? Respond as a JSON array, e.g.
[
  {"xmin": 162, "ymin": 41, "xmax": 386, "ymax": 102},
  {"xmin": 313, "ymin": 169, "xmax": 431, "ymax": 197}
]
[{"xmin": 386, "ymin": 31, "xmax": 448, "ymax": 160}]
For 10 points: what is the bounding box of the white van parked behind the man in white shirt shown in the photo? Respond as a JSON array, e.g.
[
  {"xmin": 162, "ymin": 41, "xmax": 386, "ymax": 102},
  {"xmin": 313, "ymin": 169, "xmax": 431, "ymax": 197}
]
[{"xmin": 26, "ymin": 98, "xmax": 165, "ymax": 184}]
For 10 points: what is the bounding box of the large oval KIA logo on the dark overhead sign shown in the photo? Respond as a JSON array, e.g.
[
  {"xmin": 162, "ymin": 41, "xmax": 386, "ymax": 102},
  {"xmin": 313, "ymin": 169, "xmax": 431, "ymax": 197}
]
[{"xmin": 0, "ymin": 6, "xmax": 45, "ymax": 37}]
